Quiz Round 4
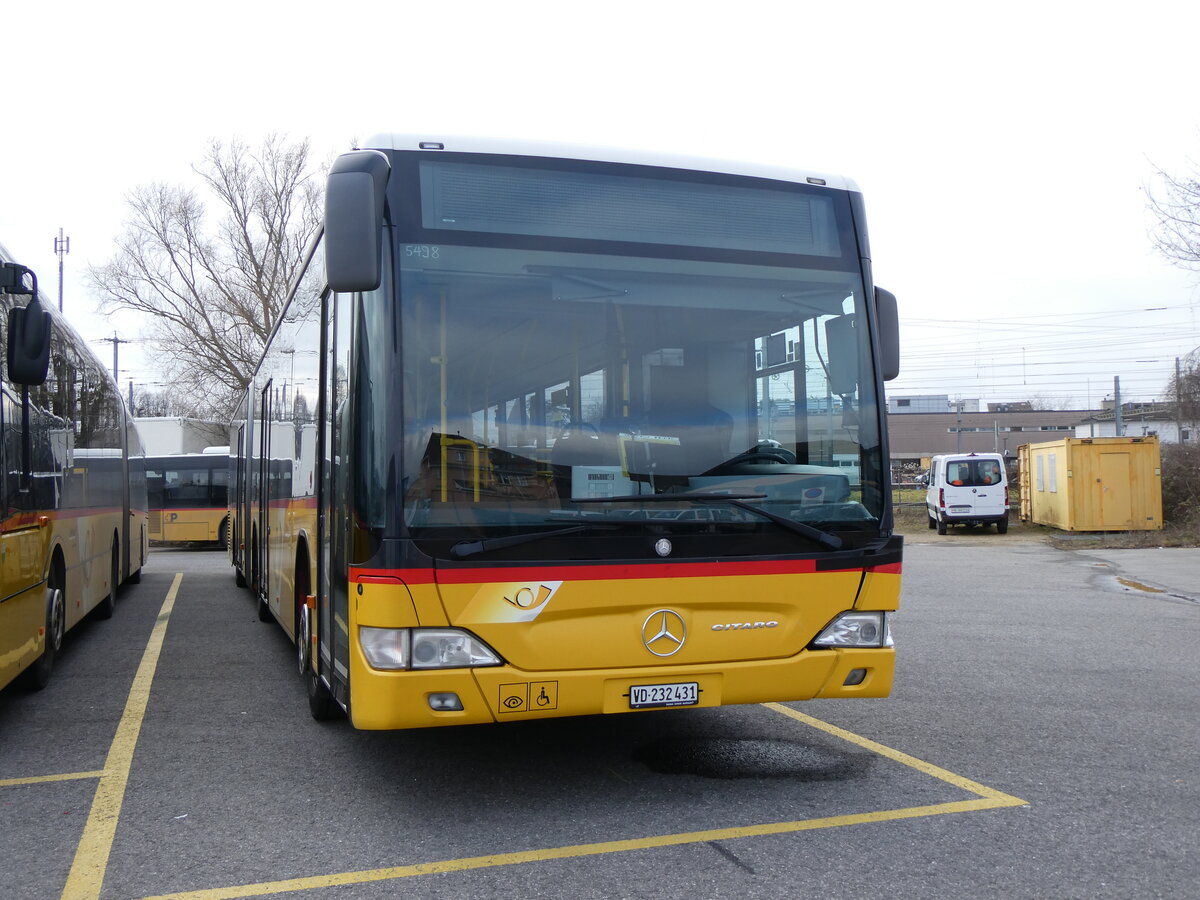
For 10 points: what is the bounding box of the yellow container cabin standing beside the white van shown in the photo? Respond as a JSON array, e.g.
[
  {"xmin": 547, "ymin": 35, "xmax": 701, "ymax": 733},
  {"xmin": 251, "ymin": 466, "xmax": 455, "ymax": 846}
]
[{"xmin": 1018, "ymin": 437, "xmax": 1163, "ymax": 532}]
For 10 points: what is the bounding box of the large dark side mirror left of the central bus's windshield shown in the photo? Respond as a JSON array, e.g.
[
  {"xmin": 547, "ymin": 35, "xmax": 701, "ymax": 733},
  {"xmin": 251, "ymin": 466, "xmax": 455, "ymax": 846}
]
[{"xmin": 325, "ymin": 150, "xmax": 391, "ymax": 293}]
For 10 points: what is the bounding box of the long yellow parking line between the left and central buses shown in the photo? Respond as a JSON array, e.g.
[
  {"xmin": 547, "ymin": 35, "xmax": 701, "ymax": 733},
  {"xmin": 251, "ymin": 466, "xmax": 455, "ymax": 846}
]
[{"xmin": 62, "ymin": 572, "xmax": 184, "ymax": 900}]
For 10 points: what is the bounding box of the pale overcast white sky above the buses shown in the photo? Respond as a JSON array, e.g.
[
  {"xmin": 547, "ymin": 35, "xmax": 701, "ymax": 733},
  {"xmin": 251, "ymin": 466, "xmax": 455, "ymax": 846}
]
[{"xmin": 0, "ymin": 0, "xmax": 1200, "ymax": 407}]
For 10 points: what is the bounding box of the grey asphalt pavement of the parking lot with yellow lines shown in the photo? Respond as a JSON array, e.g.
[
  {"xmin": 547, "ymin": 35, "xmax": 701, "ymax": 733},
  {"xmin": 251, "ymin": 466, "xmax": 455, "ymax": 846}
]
[{"xmin": 0, "ymin": 542, "xmax": 1200, "ymax": 900}]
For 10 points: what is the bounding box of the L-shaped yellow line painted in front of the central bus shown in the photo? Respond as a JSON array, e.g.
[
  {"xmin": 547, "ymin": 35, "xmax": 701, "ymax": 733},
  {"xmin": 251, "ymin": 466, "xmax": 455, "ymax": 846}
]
[{"xmin": 133, "ymin": 703, "xmax": 1028, "ymax": 900}]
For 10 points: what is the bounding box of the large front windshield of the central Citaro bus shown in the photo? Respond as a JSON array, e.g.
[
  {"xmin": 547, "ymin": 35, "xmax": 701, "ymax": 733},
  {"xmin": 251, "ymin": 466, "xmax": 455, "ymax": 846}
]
[{"xmin": 379, "ymin": 154, "xmax": 882, "ymax": 536}]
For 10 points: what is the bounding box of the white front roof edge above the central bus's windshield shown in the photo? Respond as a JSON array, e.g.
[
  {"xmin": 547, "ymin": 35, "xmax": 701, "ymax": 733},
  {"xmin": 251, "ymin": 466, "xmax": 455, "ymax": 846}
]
[{"xmin": 359, "ymin": 133, "xmax": 858, "ymax": 192}]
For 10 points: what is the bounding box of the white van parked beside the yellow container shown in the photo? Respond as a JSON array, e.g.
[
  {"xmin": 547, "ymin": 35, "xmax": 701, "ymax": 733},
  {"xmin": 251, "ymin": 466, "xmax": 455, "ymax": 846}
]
[{"xmin": 925, "ymin": 454, "xmax": 1008, "ymax": 534}]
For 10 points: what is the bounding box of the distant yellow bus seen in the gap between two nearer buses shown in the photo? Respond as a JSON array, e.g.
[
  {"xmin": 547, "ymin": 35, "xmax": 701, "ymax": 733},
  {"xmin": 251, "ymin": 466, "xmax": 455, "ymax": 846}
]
[{"xmin": 145, "ymin": 446, "xmax": 229, "ymax": 547}]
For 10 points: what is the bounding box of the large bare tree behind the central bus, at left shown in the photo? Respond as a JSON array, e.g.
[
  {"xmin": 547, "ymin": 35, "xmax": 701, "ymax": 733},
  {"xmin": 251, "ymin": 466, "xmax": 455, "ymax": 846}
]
[{"xmin": 88, "ymin": 134, "xmax": 322, "ymax": 418}]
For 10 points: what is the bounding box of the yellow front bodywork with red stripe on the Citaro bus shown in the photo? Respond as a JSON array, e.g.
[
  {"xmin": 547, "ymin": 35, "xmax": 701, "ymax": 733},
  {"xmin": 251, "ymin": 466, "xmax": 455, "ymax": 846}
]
[{"xmin": 349, "ymin": 560, "xmax": 900, "ymax": 728}]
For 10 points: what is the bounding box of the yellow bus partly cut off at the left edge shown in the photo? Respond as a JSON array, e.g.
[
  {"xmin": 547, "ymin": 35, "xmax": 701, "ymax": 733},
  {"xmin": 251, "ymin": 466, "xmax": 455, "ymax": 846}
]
[{"xmin": 0, "ymin": 247, "xmax": 149, "ymax": 689}]
